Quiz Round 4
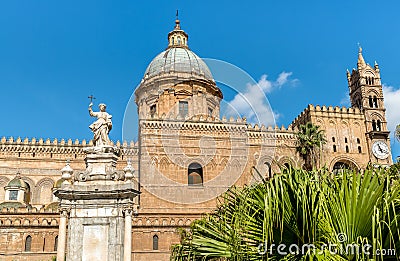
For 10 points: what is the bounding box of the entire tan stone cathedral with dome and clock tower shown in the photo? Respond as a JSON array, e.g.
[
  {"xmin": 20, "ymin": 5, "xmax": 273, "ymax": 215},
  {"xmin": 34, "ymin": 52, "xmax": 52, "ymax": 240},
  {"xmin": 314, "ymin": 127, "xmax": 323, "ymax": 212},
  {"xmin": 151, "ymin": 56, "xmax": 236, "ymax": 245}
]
[{"xmin": 0, "ymin": 19, "xmax": 392, "ymax": 261}]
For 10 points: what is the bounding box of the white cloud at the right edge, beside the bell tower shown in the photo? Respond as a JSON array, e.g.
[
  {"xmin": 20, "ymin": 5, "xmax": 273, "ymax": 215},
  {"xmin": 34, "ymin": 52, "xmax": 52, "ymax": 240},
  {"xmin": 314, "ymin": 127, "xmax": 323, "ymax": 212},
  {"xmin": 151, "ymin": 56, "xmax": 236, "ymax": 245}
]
[{"xmin": 383, "ymin": 85, "xmax": 400, "ymax": 133}]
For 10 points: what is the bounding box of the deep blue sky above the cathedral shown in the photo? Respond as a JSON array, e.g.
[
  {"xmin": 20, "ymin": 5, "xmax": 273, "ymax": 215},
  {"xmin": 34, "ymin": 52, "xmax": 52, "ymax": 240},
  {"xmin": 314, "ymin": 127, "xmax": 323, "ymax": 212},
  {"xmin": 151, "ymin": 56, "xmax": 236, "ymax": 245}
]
[{"xmin": 0, "ymin": 0, "xmax": 400, "ymax": 158}]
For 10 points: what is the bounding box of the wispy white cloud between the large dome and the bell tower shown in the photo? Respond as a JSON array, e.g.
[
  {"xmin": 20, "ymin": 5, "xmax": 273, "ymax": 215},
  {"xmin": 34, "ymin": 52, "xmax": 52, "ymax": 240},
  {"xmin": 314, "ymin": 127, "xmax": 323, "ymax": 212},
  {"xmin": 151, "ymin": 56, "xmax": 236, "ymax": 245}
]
[{"xmin": 226, "ymin": 72, "xmax": 298, "ymax": 125}]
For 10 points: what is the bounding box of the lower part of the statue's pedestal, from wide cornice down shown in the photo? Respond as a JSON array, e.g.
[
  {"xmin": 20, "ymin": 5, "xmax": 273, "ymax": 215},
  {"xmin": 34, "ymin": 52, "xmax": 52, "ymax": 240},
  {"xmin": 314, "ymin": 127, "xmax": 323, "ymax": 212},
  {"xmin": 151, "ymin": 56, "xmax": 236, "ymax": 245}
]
[{"xmin": 56, "ymin": 182, "xmax": 138, "ymax": 261}]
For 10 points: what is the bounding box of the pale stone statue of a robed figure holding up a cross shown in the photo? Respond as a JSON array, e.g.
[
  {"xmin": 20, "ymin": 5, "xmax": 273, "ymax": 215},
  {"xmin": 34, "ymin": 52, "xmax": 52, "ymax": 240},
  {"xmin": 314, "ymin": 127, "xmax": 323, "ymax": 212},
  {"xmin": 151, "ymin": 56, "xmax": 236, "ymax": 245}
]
[{"xmin": 89, "ymin": 102, "xmax": 112, "ymax": 146}]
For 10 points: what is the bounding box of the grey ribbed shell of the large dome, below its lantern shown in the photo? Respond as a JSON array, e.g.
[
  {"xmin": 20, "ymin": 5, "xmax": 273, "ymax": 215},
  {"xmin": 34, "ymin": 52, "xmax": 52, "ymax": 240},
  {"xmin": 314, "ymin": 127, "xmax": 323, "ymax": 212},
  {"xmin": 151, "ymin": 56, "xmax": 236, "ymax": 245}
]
[{"xmin": 144, "ymin": 46, "xmax": 214, "ymax": 81}]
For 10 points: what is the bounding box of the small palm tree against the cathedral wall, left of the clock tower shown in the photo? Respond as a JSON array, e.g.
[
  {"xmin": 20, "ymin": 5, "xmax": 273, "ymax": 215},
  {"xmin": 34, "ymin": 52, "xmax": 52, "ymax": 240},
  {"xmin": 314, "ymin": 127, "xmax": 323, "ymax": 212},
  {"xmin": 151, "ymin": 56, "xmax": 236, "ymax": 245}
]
[{"xmin": 296, "ymin": 122, "xmax": 326, "ymax": 170}]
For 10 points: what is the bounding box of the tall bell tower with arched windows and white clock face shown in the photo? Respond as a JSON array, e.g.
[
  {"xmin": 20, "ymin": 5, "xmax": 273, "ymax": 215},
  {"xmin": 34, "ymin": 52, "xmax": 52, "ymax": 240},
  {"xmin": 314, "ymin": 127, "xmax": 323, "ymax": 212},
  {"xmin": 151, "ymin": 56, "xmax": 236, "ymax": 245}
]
[{"xmin": 347, "ymin": 47, "xmax": 392, "ymax": 165}]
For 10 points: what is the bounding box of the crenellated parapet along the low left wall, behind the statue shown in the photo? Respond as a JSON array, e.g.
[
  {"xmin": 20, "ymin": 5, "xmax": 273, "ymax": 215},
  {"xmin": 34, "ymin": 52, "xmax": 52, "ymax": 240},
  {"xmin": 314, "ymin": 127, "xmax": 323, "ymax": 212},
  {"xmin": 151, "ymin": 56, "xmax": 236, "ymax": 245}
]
[{"xmin": 0, "ymin": 137, "xmax": 138, "ymax": 159}]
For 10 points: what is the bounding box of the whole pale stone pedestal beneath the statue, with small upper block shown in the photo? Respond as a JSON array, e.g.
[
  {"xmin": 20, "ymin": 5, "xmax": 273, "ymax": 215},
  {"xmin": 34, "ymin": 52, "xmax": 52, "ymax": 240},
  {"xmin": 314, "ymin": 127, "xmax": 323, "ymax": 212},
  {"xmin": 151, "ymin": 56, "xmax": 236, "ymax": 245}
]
[{"xmin": 55, "ymin": 147, "xmax": 139, "ymax": 261}]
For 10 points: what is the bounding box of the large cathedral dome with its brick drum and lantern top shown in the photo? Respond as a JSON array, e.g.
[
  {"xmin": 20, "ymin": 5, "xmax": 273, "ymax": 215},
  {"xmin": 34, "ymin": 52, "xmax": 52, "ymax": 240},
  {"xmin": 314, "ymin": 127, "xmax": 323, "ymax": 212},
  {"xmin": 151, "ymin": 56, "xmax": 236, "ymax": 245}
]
[{"xmin": 135, "ymin": 19, "xmax": 223, "ymax": 119}]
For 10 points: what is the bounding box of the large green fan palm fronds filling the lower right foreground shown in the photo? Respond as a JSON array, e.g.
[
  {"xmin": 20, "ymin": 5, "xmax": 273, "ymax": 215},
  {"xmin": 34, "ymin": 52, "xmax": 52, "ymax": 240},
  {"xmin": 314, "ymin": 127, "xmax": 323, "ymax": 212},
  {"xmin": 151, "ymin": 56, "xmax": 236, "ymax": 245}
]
[{"xmin": 171, "ymin": 169, "xmax": 400, "ymax": 261}]
